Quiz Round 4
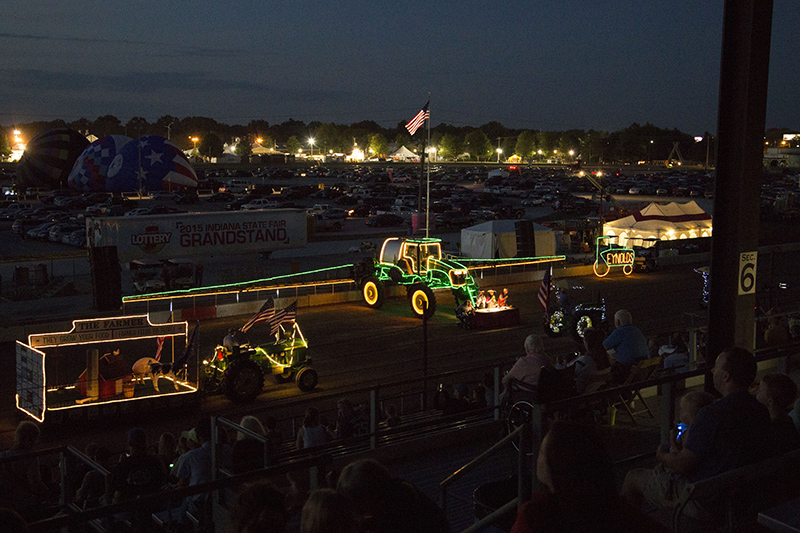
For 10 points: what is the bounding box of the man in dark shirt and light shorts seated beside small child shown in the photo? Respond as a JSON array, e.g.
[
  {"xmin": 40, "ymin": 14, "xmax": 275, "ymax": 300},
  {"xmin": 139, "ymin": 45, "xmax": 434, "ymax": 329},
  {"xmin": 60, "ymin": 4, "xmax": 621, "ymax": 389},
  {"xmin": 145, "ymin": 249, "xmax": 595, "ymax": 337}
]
[{"xmin": 622, "ymin": 347, "xmax": 774, "ymax": 520}]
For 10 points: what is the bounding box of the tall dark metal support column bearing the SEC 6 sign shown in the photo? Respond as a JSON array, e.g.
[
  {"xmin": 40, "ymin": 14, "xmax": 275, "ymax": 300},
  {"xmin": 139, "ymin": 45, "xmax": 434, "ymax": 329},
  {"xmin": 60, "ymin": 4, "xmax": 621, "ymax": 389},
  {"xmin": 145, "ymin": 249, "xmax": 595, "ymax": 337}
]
[{"xmin": 706, "ymin": 0, "xmax": 772, "ymax": 370}]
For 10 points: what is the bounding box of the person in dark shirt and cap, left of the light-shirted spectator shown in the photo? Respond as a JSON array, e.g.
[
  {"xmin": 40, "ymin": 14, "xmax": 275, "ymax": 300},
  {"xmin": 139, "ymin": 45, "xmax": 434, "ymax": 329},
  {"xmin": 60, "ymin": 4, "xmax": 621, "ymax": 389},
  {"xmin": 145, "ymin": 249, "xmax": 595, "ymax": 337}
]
[{"xmin": 111, "ymin": 428, "xmax": 167, "ymax": 503}]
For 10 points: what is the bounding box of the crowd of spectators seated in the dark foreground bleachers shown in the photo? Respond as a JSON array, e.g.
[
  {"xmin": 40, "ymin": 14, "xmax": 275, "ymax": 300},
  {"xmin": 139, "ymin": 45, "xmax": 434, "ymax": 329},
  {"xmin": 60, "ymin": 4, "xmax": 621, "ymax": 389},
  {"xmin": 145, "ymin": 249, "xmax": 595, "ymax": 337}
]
[{"xmin": 0, "ymin": 310, "xmax": 800, "ymax": 533}]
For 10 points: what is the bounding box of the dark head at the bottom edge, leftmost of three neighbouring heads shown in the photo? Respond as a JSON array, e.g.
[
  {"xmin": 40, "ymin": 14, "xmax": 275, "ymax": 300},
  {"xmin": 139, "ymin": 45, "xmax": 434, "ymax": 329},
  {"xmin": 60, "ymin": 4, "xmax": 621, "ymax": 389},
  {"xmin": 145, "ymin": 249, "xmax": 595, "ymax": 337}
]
[{"xmin": 230, "ymin": 481, "xmax": 289, "ymax": 533}]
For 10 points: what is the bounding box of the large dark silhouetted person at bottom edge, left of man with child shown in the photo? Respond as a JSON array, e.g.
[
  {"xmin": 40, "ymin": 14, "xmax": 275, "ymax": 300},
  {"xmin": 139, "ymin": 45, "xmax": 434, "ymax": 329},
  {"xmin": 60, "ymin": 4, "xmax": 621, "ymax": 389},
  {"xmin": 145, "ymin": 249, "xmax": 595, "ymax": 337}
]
[{"xmin": 511, "ymin": 421, "xmax": 653, "ymax": 533}]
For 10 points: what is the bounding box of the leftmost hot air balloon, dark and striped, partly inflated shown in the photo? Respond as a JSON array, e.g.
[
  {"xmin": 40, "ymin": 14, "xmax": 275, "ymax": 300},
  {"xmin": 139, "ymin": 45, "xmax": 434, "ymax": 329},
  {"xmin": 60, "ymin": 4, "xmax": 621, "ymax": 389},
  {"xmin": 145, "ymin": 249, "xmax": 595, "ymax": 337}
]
[{"xmin": 17, "ymin": 128, "xmax": 89, "ymax": 189}]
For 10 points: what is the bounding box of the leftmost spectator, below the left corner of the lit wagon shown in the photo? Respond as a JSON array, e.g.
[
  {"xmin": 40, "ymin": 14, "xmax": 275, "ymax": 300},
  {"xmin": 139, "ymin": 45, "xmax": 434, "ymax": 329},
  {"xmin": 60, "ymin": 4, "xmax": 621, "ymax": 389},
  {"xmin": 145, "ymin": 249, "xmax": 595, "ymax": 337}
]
[{"xmin": 0, "ymin": 420, "xmax": 49, "ymax": 518}]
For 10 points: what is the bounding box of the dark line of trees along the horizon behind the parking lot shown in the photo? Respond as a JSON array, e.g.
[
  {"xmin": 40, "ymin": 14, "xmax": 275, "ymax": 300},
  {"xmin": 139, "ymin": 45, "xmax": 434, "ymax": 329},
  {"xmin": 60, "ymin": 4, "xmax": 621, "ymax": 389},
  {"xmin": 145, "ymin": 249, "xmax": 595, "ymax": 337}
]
[{"xmin": 2, "ymin": 115, "xmax": 788, "ymax": 164}]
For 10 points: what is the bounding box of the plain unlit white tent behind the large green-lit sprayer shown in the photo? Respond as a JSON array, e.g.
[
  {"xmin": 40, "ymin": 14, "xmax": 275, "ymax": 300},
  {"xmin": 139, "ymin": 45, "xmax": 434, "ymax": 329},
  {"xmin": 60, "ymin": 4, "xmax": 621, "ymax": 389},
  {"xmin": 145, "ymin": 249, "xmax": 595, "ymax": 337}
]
[{"xmin": 461, "ymin": 220, "xmax": 556, "ymax": 259}]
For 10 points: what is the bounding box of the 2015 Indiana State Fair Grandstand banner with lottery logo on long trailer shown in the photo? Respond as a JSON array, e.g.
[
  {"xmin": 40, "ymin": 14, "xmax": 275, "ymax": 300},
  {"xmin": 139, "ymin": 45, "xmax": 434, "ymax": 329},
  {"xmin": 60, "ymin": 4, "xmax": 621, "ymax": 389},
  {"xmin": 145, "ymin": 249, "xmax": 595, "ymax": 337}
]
[{"xmin": 86, "ymin": 209, "xmax": 307, "ymax": 262}]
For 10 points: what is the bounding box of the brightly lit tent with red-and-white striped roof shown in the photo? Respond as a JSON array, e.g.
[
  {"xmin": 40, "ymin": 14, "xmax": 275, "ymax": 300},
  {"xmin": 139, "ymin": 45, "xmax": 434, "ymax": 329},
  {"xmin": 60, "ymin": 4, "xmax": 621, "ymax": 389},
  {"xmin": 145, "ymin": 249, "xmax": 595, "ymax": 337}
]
[{"xmin": 603, "ymin": 202, "xmax": 712, "ymax": 246}]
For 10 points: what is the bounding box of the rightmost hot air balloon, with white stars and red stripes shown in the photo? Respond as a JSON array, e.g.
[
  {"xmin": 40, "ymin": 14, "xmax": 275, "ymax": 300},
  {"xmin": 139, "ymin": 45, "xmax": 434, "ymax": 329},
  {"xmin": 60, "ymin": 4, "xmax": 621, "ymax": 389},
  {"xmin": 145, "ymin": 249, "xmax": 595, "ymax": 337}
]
[{"xmin": 105, "ymin": 135, "xmax": 197, "ymax": 192}]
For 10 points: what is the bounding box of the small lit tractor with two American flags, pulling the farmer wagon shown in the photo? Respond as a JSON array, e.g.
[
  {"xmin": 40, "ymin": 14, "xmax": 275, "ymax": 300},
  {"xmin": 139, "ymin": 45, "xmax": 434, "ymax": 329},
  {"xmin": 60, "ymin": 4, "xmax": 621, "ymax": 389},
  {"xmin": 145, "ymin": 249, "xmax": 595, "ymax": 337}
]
[{"xmin": 201, "ymin": 322, "xmax": 318, "ymax": 403}]
